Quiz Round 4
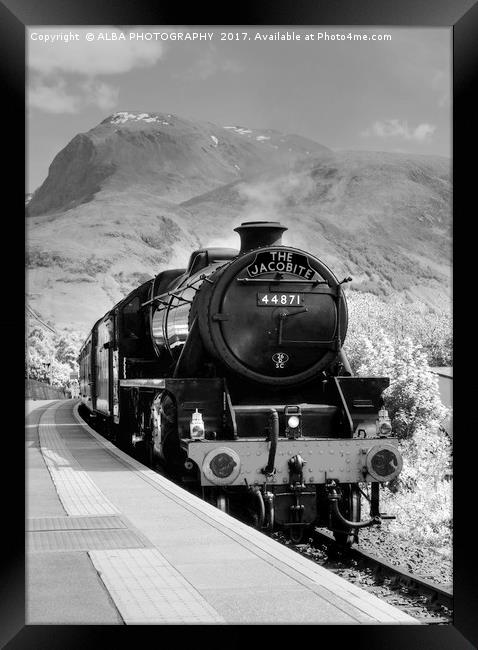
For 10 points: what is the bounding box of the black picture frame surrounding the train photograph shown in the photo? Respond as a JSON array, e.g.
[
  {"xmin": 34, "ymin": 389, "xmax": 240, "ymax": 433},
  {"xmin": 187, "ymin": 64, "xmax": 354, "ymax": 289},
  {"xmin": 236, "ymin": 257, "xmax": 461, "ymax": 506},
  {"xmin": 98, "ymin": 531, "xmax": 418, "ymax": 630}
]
[{"xmin": 5, "ymin": 0, "xmax": 478, "ymax": 650}]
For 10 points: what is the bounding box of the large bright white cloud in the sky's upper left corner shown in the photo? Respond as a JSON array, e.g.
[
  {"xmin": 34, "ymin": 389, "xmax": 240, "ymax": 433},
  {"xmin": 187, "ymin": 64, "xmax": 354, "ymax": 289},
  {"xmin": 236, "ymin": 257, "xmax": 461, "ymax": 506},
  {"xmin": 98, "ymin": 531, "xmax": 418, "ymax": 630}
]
[{"xmin": 28, "ymin": 27, "xmax": 166, "ymax": 114}]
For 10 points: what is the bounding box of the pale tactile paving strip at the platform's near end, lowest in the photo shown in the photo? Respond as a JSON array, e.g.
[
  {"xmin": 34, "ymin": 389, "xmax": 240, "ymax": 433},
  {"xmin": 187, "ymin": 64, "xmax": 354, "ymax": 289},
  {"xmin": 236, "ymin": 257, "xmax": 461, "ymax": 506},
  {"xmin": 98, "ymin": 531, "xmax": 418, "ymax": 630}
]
[{"xmin": 89, "ymin": 549, "xmax": 225, "ymax": 625}]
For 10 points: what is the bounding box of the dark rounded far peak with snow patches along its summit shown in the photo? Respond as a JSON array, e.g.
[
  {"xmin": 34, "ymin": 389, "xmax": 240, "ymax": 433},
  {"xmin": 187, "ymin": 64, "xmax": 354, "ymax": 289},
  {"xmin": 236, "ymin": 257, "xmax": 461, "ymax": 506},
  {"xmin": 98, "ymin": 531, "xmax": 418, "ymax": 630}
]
[{"xmin": 29, "ymin": 112, "xmax": 329, "ymax": 215}]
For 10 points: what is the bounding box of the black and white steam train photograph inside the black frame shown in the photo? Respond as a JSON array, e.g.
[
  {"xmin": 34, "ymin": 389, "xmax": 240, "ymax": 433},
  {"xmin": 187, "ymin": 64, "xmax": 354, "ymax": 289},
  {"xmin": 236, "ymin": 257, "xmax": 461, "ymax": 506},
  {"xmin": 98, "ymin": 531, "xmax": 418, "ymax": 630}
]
[{"xmin": 21, "ymin": 24, "xmax": 454, "ymax": 626}]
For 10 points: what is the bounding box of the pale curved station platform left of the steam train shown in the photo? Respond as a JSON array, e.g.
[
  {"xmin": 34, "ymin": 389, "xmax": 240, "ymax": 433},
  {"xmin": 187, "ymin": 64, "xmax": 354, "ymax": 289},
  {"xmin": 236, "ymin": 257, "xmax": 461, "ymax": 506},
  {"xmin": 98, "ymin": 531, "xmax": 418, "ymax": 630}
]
[{"xmin": 26, "ymin": 400, "xmax": 418, "ymax": 625}]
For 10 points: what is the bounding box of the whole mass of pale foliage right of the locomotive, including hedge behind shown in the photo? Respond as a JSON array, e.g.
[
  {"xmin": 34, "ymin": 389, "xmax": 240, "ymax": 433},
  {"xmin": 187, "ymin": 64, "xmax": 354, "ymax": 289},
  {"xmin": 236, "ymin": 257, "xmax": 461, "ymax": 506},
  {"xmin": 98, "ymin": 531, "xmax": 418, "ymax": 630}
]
[{"xmin": 345, "ymin": 294, "xmax": 452, "ymax": 549}]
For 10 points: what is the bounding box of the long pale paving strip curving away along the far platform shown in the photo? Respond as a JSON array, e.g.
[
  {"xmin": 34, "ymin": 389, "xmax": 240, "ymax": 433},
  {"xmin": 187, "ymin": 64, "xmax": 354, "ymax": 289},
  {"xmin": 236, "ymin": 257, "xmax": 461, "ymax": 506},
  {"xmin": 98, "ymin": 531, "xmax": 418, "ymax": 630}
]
[{"xmin": 38, "ymin": 402, "xmax": 119, "ymax": 515}]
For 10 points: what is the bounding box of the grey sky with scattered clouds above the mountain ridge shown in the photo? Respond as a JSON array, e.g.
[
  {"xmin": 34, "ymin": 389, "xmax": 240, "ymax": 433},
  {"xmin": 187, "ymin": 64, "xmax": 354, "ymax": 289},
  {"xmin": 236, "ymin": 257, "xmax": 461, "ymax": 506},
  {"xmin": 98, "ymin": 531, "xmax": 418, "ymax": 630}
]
[{"xmin": 26, "ymin": 25, "xmax": 452, "ymax": 192}]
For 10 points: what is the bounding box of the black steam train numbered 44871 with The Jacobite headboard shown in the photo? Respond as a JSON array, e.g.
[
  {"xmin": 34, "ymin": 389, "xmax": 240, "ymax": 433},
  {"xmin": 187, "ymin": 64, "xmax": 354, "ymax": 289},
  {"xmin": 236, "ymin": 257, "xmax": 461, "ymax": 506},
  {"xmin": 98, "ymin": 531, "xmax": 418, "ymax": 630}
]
[{"xmin": 79, "ymin": 221, "xmax": 402, "ymax": 544}]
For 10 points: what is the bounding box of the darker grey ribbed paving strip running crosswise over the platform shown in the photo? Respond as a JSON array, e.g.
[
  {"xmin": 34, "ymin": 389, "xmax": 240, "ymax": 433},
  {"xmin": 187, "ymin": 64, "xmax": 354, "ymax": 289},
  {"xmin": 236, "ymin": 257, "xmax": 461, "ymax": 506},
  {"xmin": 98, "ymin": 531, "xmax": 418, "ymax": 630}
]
[{"xmin": 27, "ymin": 528, "xmax": 144, "ymax": 553}]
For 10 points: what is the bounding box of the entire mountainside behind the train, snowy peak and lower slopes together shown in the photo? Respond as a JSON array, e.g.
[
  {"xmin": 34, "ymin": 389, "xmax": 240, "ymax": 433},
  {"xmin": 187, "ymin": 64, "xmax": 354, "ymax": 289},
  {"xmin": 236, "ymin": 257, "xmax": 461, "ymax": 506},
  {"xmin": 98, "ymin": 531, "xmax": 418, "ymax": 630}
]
[{"xmin": 26, "ymin": 112, "xmax": 451, "ymax": 331}]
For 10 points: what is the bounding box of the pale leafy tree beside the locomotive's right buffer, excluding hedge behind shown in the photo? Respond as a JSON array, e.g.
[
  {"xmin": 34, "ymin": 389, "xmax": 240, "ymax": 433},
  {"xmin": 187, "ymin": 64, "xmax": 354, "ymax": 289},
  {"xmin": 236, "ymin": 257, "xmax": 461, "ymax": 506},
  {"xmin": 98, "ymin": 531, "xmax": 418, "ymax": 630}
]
[{"xmin": 350, "ymin": 321, "xmax": 452, "ymax": 549}]
